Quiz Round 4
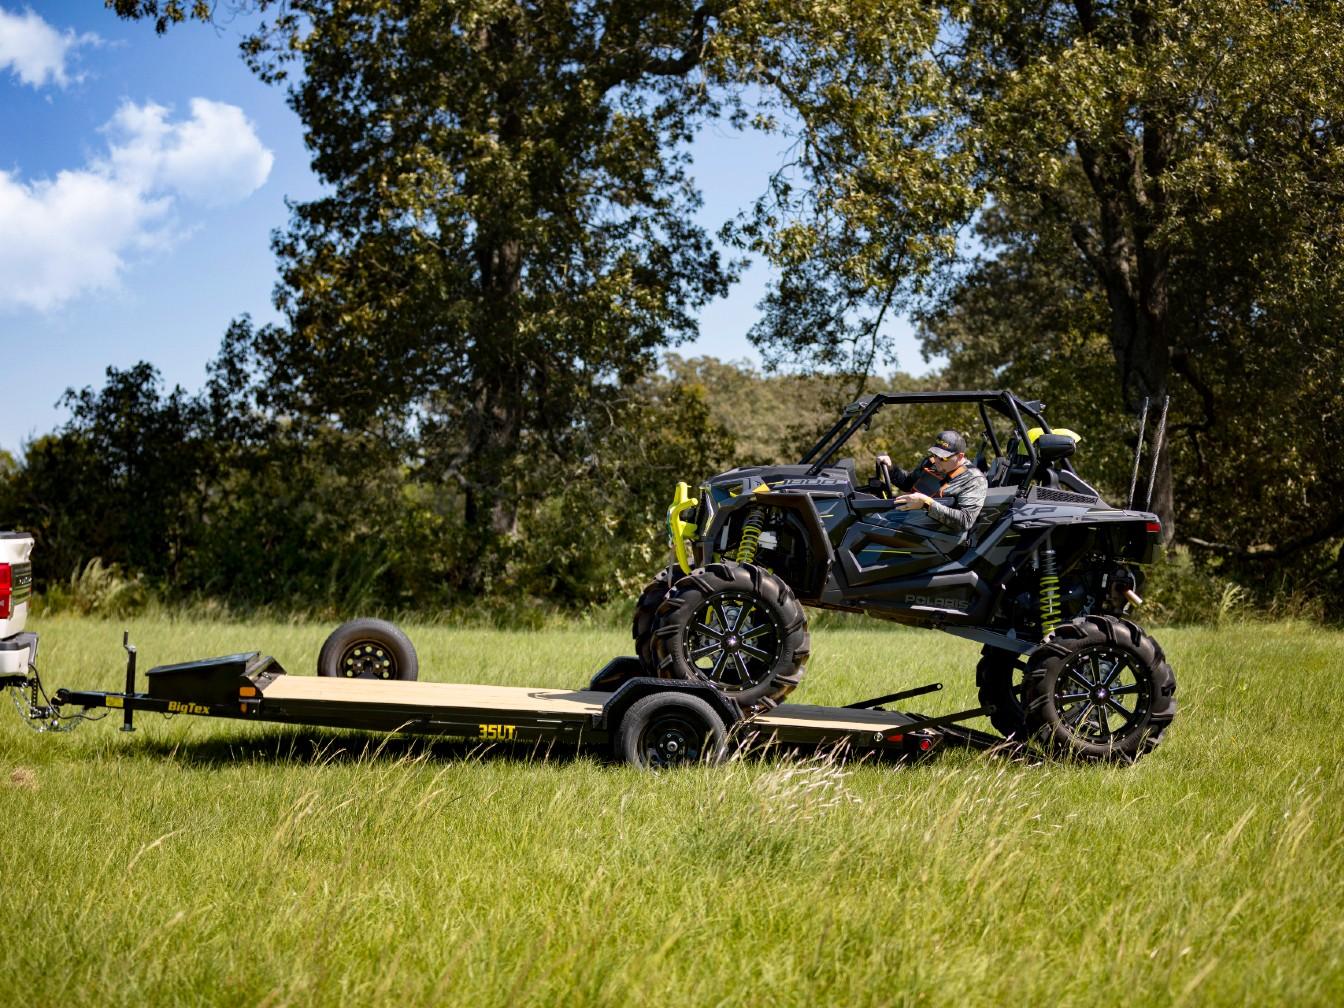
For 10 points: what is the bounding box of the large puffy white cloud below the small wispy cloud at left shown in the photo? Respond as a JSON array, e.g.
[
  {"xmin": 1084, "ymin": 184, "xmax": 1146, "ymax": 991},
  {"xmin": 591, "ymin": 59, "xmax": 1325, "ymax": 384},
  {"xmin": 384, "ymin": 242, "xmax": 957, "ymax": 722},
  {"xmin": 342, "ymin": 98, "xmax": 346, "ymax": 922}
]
[{"xmin": 0, "ymin": 98, "xmax": 274, "ymax": 310}]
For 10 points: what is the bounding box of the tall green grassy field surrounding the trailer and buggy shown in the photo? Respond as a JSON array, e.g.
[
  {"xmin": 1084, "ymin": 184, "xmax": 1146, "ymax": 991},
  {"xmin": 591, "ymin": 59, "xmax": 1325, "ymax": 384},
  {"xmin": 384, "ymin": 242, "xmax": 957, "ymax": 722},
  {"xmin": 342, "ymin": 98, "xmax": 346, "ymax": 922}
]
[{"xmin": 0, "ymin": 617, "xmax": 1344, "ymax": 1008}]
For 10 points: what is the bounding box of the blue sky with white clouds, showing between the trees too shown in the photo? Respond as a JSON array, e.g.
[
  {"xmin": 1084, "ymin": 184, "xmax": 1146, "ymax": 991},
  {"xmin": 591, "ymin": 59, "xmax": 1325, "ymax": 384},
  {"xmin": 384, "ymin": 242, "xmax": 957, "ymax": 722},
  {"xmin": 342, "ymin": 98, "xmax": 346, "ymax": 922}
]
[{"xmin": 0, "ymin": 0, "xmax": 927, "ymax": 453}]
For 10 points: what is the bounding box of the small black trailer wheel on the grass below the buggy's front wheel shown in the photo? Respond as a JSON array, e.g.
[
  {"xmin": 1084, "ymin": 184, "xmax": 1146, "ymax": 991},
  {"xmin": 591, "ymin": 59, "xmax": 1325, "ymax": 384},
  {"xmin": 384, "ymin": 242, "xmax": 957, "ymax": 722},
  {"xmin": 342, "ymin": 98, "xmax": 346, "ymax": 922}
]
[{"xmin": 616, "ymin": 692, "xmax": 728, "ymax": 770}]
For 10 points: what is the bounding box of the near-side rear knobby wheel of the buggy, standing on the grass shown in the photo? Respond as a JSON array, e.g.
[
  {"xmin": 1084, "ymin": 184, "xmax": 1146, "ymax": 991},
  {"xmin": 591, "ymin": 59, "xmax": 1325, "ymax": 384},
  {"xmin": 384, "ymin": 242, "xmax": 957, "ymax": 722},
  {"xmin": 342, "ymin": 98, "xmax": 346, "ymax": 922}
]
[{"xmin": 1025, "ymin": 616, "xmax": 1176, "ymax": 762}]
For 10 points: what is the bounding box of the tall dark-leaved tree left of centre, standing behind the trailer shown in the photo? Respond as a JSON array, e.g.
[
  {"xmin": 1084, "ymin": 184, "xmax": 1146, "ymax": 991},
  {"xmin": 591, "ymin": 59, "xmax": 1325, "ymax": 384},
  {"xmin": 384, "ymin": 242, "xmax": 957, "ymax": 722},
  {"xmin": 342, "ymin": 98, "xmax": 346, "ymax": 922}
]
[{"xmin": 225, "ymin": 0, "xmax": 731, "ymax": 583}]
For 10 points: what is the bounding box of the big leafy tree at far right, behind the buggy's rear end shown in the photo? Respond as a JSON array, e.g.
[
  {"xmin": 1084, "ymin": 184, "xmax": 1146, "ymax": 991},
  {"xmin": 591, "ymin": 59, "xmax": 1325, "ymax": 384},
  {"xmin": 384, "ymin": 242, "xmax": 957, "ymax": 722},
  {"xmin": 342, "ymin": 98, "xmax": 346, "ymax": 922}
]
[{"xmin": 927, "ymin": 4, "xmax": 1344, "ymax": 578}]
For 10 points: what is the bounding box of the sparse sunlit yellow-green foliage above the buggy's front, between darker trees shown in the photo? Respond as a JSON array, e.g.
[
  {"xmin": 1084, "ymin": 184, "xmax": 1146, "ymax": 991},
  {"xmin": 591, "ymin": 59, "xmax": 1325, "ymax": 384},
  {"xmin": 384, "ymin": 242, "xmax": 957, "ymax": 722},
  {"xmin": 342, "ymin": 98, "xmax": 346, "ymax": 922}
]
[{"xmin": 715, "ymin": 0, "xmax": 977, "ymax": 401}]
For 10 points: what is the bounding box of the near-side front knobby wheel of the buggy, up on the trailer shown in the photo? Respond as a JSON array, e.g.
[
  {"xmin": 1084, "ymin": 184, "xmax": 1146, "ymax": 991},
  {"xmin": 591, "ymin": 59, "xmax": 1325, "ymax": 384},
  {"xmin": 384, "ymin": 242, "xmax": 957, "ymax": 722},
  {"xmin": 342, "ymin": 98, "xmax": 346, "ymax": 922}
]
[{"xmin": 653, "ymin": 563, "xmax": 812, "ymax": 707}]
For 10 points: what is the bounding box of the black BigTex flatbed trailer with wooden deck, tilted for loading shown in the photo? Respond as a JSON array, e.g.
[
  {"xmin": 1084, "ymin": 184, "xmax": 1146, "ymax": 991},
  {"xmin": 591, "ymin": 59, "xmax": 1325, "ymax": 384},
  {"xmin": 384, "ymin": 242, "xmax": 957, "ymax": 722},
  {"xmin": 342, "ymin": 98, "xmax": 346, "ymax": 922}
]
[{"xmin": 0, "ymin": 634, "xmax": 1008, "ymax": 769}]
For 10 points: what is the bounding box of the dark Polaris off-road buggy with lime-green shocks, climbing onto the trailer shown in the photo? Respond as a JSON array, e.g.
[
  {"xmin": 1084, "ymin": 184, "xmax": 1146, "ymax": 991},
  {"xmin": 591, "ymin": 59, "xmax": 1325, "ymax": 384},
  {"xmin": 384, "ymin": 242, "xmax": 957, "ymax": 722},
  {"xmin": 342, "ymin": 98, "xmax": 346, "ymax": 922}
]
[{"xmin": 633, "ymin": 391, "xmax": 1176, "ymax": 759}]
